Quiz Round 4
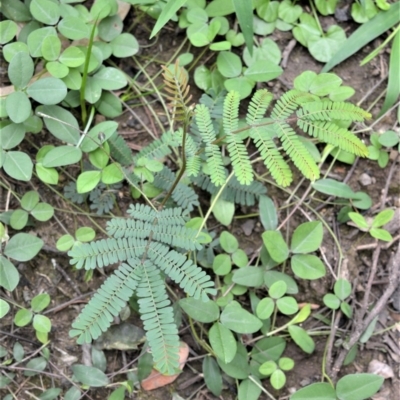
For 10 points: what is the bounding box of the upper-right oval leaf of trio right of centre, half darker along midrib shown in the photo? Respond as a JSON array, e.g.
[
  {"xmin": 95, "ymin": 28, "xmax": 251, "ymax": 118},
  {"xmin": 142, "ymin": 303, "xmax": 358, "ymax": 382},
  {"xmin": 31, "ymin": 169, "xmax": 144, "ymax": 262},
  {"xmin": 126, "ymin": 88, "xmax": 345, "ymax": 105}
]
[{"xmin": 290, "ymin": 221, "xmax": 323, "ymax": 253}]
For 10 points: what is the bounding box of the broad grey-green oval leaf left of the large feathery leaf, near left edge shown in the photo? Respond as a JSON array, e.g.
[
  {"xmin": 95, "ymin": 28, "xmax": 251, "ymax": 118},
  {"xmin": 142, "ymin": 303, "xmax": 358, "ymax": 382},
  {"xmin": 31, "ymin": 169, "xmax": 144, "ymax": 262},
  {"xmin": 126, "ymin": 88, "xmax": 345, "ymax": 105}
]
[{"xmin": 4, "ymin": 233, "xmax": 44, "ymax": 262}]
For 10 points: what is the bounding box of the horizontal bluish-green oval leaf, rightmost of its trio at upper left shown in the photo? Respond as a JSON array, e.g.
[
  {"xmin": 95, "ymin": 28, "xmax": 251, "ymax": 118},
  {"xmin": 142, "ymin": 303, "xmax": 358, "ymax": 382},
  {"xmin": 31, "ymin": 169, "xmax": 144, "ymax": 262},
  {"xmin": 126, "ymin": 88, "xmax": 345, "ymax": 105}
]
[{"xmin": 27, "ymin": 77, "xmax": 67, "ymax": 105}]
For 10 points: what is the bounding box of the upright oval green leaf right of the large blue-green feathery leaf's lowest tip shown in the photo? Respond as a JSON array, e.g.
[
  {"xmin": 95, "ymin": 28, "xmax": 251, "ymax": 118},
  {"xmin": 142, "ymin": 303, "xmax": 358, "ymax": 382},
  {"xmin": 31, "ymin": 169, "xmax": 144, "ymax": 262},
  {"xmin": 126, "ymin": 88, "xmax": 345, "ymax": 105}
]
[{"xmin": 208, "ymin": 322, "xmax": 237, "ymax": 363}]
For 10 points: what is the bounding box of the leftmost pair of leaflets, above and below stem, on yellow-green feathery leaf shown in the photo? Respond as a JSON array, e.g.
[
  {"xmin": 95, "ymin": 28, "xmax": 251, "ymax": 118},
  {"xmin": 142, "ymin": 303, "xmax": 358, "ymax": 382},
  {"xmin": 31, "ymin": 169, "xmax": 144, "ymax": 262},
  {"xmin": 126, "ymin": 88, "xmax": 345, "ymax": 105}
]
[{"xmin": 195, "ymin": 104, "xmax": 226, "ymax": 186}]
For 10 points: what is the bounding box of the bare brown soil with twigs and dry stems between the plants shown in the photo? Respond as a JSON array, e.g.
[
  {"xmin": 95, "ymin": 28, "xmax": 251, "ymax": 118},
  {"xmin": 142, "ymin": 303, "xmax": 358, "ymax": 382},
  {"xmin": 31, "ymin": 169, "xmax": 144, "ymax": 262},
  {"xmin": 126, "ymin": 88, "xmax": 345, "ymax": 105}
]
[{"xmin": 0, "ymin": 7, "xmax": 400, "ymax": 400}]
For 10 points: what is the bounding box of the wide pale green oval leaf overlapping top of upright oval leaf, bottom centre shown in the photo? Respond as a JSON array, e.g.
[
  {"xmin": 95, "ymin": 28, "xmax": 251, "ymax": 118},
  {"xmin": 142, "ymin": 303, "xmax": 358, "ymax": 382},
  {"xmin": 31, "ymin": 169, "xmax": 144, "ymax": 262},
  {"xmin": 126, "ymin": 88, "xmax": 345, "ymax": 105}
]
[{"xmin": 220, "ymin": 301, "xmax": 262, "ymax": 334}]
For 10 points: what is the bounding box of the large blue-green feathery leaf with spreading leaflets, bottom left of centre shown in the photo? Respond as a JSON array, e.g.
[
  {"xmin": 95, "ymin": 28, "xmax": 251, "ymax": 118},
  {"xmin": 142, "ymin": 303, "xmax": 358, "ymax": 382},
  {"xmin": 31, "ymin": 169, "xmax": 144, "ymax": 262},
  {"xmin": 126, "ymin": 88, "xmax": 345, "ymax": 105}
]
[{"xmin": 68, "ymin": 204, "xmax": 216, "ymax": 375}]
